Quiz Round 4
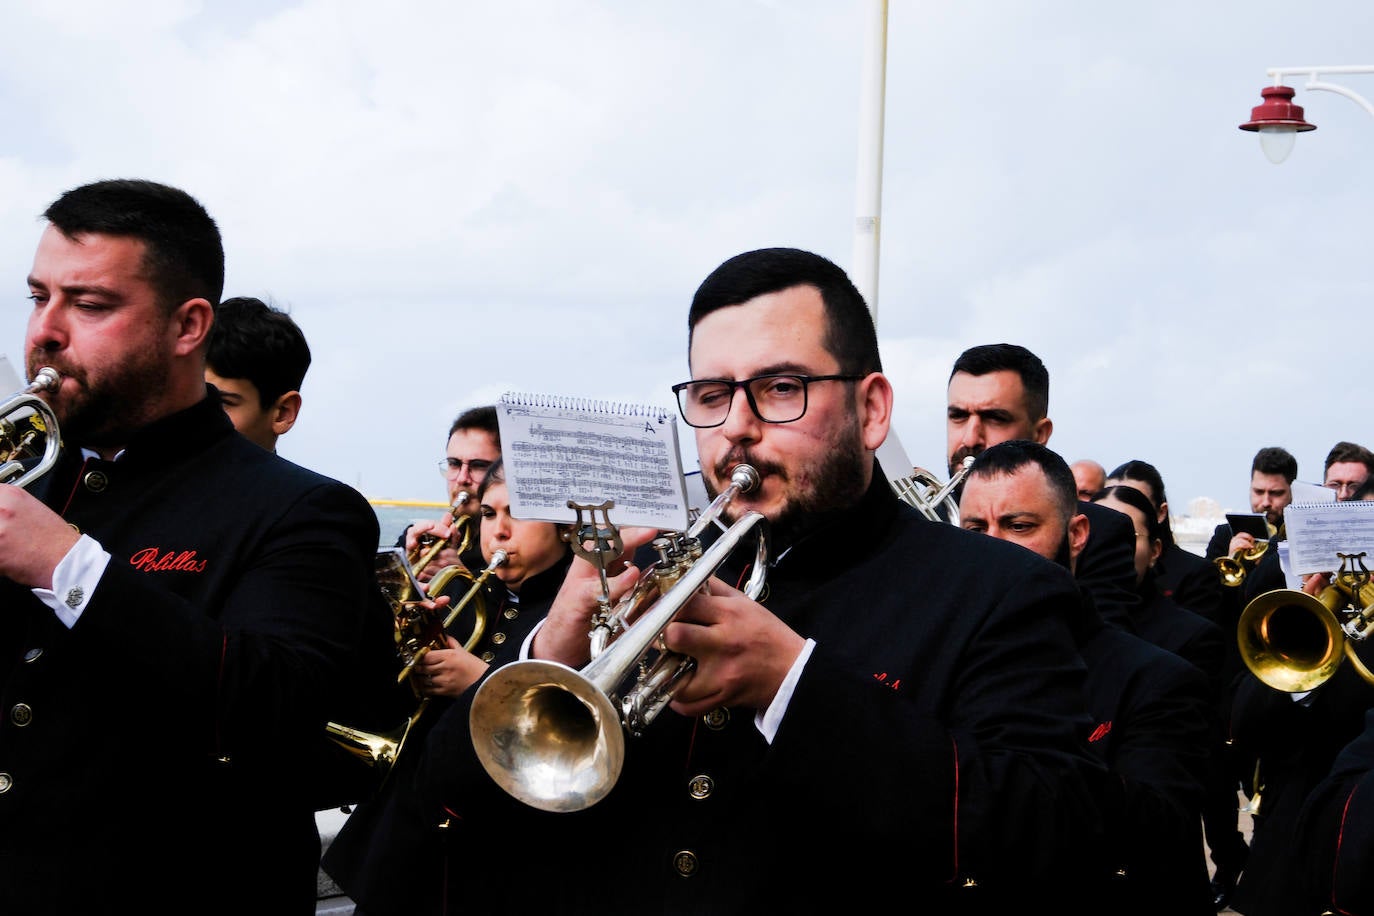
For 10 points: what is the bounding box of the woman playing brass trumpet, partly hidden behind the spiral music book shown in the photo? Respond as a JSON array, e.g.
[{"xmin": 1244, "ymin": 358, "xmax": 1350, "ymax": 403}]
[{"xmin": 322, "ymin": 459, "xmax": 572, "ymax": 916}]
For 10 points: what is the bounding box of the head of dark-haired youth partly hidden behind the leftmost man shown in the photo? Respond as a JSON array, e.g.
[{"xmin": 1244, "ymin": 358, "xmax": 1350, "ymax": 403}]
[{"xmin": 205, "ymin": 297, "xmax": 311, "ymax": 452}]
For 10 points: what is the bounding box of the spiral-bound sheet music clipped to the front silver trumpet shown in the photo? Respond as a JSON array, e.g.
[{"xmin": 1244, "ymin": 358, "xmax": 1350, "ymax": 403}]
[{"xmin": 496, "ymin": 391, "xmax": 688, "ymax": 530}]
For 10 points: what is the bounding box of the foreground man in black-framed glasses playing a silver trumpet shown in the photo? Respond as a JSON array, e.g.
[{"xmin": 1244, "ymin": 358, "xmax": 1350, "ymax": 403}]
[{"xmin": 418, "ymin": 249, "xmax": 1106, "ymax": 913}]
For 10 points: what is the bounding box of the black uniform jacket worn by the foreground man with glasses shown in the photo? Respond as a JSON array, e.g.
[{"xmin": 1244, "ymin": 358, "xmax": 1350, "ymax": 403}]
[{"xmin": 419, "ymin": 472, "xmax": 1105, "ymax": 915}]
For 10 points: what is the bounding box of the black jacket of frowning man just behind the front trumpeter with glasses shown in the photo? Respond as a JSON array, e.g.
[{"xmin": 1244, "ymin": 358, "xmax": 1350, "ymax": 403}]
[{"xmin": 1077, "ymin": 595, "xmax": 1216, "ymax": 916}]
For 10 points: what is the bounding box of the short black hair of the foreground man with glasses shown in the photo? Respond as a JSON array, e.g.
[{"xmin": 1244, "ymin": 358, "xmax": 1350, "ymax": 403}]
[{"xmin": 687, "ymin": 249, "xmax": 882, "ymax": 375}]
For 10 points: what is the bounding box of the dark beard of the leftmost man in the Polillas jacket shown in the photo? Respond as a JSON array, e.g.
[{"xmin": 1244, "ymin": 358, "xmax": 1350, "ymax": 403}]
[{"xmin": 27, "ymin": 349, "xmax": 166, "ymax": 448}]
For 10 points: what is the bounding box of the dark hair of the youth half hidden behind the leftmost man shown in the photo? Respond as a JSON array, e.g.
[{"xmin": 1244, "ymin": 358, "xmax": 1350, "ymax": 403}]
[{"xmin": 205, "ymin": 295, "xmax": 311, "ymax": 407}]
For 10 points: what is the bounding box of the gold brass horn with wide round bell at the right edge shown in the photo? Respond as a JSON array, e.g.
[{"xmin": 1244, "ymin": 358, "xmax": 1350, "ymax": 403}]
[{"xmin": 1237, "ymin": 553, "xmax": 1374, "ymax": 694}]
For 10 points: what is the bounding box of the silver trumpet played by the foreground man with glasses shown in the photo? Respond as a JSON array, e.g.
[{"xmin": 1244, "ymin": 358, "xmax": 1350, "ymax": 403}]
[{"xmin": 469, "ymin": 464, "xmax": 768, "ymax": 812}]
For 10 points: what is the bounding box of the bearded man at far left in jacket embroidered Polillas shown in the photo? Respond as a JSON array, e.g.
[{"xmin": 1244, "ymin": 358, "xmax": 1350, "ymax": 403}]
[{"xmin": 0, "ymin": 180, "xmax": 394, "ymax": 915}]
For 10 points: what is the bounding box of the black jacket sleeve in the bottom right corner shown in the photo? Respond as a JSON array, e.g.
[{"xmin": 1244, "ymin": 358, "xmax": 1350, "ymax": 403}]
[{"xmin": 1293, "ymin": 711, "xmax": 1374, "ymax": 916}]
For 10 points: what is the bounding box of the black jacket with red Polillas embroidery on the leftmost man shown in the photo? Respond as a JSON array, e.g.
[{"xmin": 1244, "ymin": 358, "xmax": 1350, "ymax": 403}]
[{"xmin": 0, "ymin": 390, "xmax": 387, "ymax": 913}]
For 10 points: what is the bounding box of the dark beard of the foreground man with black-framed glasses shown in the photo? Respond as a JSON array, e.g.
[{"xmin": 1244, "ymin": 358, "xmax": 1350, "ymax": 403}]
[{"xmin": 708, "ymin": 415, "xmax": 867, "ymax": 545}]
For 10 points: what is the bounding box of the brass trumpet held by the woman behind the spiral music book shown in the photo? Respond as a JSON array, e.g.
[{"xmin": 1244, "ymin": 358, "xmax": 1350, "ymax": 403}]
[{"xmin": 324, "ymin": 549, "xmax": 508, "ymax": 779}]
